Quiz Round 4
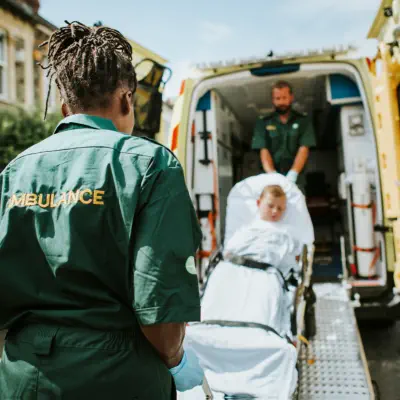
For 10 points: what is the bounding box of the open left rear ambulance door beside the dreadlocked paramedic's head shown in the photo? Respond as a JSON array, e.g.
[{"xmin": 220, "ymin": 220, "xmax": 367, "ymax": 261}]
[{"xmin": 133, "ymin": 58, "xmax": 171, "ymax": 138}]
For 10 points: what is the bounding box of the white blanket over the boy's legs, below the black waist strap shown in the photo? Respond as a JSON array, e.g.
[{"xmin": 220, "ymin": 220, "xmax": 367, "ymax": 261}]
[{"xmin": 179, "ymin": 261, "xmax": 297, "ymax": 400}]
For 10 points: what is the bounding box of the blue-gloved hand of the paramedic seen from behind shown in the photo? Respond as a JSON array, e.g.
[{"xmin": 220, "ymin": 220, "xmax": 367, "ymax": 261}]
[{"xmin": 169, "ymin": 349, "xmax": 204, "ymax": 392}]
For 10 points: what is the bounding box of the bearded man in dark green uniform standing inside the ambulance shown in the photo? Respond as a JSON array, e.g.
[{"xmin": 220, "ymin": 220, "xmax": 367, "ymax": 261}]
[{"xmin": 252, "ymin": 81, "xmax": 316, "ymax": 191}]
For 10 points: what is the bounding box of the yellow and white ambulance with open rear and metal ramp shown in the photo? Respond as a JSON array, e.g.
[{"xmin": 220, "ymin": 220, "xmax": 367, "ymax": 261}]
[{"xmin": 168, "ymin": 0, "xmax": 400, "ymax": 399}]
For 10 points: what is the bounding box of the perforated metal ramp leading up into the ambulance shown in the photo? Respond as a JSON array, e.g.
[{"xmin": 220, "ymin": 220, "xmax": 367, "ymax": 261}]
[{"xmin": 298, "ymin": 283, "xmax": 374, "ymax": 400}]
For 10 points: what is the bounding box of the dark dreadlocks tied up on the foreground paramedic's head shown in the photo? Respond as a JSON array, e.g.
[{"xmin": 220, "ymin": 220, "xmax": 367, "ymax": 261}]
[{"xmin": 40, "ymin": 21, "xmax": 137, "ymax": 119}]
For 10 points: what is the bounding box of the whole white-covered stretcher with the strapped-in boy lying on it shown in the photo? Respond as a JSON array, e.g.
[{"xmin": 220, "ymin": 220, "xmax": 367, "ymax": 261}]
[{"xmin": 180, "ymin": 174, "xmax": 314, "ymax": 400}]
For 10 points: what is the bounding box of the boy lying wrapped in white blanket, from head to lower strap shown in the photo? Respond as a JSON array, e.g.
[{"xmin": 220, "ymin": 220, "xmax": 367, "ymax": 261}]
[{"xmin": 202, "ymin": 185, "xmax": 301, "ymax": 337}]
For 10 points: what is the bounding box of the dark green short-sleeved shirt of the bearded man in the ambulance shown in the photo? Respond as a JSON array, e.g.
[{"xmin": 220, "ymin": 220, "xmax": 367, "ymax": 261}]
[{"xmin": 252, "ymin": 110, "xmax": 316, "ymax": 174}]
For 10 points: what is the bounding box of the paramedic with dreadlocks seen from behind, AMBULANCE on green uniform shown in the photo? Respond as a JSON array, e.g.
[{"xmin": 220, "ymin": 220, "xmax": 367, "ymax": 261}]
[{"xmin": 0, "ymin": 22, "xmax": 204, "ymax": 400}]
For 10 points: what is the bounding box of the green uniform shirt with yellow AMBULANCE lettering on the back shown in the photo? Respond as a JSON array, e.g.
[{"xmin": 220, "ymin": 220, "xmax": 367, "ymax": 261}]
[{"xmin": 0, "ymin": 115, "xmax": 201, "ymax": 330}]
